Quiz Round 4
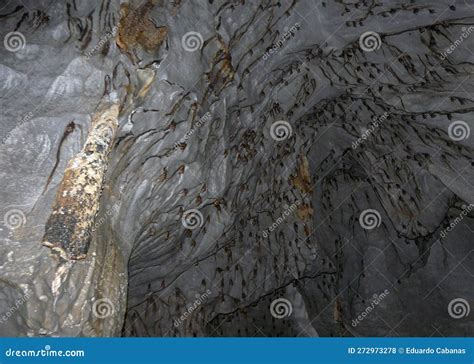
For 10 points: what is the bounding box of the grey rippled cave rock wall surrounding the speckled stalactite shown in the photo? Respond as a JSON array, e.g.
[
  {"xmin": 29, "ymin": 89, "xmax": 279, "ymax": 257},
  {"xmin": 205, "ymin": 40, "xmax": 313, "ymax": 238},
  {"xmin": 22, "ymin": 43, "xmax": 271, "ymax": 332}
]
[{"xmin": 0, "ymin": 0, "xmax": 474, "ymax": 336}]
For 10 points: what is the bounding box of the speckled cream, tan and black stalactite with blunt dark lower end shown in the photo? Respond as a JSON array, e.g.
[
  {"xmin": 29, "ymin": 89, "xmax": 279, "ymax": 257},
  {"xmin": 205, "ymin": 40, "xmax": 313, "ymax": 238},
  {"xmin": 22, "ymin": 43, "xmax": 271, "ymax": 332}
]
[{"xmin": 43, "ymin": 99, "xmax": 119, "ymax": 260}]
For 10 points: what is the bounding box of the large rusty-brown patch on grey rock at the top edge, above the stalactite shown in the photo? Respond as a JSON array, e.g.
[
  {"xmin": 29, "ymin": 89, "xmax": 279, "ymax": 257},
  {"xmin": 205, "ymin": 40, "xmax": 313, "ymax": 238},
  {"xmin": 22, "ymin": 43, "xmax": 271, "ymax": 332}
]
[{"xmin": 115, "ymin": 0, "xmax": 168, "ymax": 61}]
